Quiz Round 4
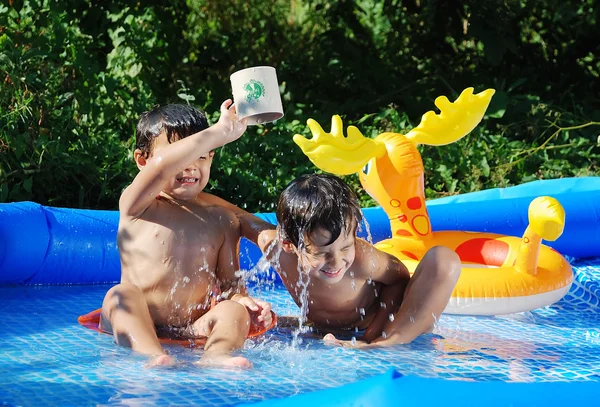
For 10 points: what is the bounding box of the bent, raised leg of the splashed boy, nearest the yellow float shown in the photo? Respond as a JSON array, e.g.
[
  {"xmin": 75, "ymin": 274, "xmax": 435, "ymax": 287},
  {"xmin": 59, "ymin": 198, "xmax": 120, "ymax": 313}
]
[{"xmin": 373, "ymin": 246, "xmax": 462, "ymax": 344}]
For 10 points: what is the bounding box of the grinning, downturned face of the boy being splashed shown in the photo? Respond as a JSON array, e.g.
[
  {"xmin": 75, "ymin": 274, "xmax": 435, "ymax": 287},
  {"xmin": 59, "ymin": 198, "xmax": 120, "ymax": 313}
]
[{"xmin": 295, "ymin": 228, "xmax": 356, "ymax": 284}]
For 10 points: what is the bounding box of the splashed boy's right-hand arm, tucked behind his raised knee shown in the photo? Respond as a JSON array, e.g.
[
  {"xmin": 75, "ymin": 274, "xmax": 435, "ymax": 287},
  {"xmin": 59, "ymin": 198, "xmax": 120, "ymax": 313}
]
[{"xmin": 361, "ymin": 242, "xmax": 410, "ymax": 342}]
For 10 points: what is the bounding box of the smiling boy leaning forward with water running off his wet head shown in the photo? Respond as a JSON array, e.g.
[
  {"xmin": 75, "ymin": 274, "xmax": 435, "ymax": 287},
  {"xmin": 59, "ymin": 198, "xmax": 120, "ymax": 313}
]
[{"xmin": 223, "ymin": 174, "xmax": 461, "ymax": 348}]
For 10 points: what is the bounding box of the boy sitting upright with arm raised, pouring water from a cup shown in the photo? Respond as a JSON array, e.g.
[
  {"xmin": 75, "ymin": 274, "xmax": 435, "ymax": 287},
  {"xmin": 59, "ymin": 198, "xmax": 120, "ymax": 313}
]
[{"xmin": 100, "ymin": 100, "xmax": 271, "ymax": 367}]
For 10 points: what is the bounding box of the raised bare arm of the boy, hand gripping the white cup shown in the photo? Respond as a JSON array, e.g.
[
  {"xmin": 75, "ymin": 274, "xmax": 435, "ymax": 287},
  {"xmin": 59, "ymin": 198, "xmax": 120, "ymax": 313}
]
[{"xmin": 119, "ymin": 100, "xmax": 246, "ymax": 218}]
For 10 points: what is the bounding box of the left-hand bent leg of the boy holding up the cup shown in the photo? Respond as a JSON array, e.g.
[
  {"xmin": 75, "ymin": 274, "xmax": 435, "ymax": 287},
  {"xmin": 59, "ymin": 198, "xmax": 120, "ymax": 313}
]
[{"xmin": 100, "ymin": 283, "xmax": 171, "ymax": 364}]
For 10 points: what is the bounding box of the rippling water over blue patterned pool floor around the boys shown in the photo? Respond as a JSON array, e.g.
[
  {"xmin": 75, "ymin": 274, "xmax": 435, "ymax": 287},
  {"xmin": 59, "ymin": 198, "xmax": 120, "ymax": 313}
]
[{"xmin": 0, "ymin": 259, "xmax": 600, "ymax": 406}]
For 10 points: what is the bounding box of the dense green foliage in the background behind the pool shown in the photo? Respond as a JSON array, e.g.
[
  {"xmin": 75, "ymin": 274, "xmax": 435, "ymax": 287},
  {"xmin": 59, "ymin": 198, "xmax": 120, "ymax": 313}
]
[{"xmin": 0, "ymin": 0, "xmax": 600, "ymax": 211}]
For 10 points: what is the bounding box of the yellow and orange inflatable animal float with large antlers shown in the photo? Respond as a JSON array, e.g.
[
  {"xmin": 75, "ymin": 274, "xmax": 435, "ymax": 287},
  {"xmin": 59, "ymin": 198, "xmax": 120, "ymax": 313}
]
[{"xmin": 294, "ymin": 88, "xmax": 573, "ymax": 315}]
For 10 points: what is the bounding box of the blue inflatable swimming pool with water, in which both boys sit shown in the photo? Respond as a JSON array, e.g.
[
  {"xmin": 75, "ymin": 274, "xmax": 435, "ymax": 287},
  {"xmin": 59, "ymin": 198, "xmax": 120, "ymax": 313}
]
[{"xmin": 0, "ymin": 178, "xmax": 600, "ymax": 406}]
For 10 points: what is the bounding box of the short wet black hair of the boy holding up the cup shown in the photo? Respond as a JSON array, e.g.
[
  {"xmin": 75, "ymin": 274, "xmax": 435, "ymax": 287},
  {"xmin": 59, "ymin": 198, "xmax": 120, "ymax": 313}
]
[{"xmin": 135, "ymin": 104, "xmax": 209, "ymax": 158}]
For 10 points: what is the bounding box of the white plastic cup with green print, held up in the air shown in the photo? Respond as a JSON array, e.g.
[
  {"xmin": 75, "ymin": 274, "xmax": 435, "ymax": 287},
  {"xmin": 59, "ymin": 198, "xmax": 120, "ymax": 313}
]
[{"xmin": 229, "ymin": 66, "xmax": 283, "ymax": 126}]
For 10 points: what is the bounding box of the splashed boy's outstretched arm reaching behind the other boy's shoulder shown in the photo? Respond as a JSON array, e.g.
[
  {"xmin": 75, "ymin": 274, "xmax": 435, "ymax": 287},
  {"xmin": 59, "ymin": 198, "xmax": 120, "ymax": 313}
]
[{"xmin": 201, "ymin": 192, "xmax": 276, "ymax": 253}]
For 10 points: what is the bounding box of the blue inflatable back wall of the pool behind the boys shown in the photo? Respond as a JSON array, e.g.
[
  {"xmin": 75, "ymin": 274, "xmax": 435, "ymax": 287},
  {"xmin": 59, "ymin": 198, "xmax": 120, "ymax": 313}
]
[{"xmin": 0, "ymin": 177, "xmax": 600, "ymax": 284}]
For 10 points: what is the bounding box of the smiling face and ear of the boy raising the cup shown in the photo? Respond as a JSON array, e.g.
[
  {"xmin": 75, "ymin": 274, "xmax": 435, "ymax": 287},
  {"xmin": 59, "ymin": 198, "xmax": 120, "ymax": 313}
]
[{"xmin": 142, "ymin": 133, "xmax": 214, "ymax": 200}]
